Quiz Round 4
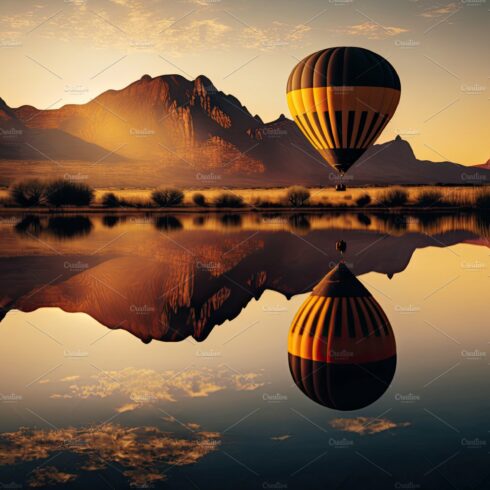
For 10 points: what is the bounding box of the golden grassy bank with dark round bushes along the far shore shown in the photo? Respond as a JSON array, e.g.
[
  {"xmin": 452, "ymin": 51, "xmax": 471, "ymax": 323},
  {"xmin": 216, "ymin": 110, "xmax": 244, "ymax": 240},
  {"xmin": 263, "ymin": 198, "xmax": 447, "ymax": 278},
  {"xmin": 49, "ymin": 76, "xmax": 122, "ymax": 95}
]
[{"xmin": 0, "ymin": 180, "xmax": 490, "ymax": 212}]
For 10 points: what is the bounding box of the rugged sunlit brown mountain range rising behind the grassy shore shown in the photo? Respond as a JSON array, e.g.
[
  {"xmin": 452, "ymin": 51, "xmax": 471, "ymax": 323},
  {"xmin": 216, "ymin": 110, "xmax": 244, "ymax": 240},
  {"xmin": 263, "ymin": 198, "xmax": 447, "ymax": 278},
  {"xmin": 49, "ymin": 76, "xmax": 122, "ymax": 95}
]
[{"xmin": 0, "ymin": 75, "xmax": 490, "ymax": 187}]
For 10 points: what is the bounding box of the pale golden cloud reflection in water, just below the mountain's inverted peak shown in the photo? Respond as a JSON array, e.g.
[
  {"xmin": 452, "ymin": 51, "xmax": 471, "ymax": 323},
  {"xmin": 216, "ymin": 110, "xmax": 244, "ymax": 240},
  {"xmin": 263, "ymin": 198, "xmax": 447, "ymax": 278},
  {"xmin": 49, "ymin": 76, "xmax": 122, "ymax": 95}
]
[{"xmin": 51, "ymin": 366, "xmax": 265, "ymax": 404}]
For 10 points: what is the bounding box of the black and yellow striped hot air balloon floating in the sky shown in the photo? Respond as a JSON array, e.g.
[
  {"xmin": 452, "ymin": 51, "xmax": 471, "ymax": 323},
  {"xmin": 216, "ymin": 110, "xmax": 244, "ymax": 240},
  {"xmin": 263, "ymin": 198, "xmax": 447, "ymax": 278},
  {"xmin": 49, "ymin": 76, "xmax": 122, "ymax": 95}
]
[{"xmin": 287, "ymin": 47, "xmax": 401, "ymax": 179}]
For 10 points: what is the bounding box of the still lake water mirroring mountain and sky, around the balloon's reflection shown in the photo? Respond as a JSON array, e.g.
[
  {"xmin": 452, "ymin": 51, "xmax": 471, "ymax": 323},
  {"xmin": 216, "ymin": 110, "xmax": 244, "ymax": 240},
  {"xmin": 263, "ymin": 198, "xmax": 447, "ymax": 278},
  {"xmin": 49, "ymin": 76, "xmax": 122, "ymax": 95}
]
[{"xmin": 0, "ymin": 213, "xmax": 490, "ymax": 490}]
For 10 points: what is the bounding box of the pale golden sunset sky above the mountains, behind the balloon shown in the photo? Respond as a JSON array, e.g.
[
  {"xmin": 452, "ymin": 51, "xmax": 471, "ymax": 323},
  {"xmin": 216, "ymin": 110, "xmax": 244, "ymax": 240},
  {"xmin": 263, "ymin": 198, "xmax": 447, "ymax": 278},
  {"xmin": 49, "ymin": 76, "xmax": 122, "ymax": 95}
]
[{"xmin": 0, "ymin": 0, "xmax": 490, "ymax": 165}]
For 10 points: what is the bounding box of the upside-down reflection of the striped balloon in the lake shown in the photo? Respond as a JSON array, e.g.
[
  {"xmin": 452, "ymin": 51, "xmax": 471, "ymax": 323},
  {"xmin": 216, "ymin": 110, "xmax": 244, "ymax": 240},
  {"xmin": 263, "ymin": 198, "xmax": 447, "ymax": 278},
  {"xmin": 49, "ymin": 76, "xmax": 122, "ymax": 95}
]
[{"xmin": 288, "ymin": 262, "xmax": 396, "ymax": 410}]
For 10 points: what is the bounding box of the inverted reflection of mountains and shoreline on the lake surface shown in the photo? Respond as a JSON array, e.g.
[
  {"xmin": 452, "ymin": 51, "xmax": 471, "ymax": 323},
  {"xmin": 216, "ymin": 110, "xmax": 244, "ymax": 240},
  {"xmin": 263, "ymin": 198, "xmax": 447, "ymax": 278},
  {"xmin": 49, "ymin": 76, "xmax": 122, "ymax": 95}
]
[{"xmin": 0, "ymin": 213, "xmax": 488, "ymax": 342}]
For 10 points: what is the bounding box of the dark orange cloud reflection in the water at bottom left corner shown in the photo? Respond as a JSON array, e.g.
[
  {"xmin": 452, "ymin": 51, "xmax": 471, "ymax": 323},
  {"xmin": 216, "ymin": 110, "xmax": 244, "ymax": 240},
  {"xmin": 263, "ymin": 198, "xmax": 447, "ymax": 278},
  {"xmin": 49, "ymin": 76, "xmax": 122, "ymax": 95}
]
[{"xmin": 0, "ymin": 423, "xmax": 220, "ymax": 487}]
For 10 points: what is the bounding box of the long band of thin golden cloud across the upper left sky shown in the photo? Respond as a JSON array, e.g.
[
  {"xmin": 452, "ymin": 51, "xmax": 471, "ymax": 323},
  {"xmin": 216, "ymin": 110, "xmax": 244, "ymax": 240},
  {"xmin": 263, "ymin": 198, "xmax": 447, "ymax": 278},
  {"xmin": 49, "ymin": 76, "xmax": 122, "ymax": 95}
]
[{"xmin": 0, "ymin": 0, "xmax": 311, "ymax": 57}]
